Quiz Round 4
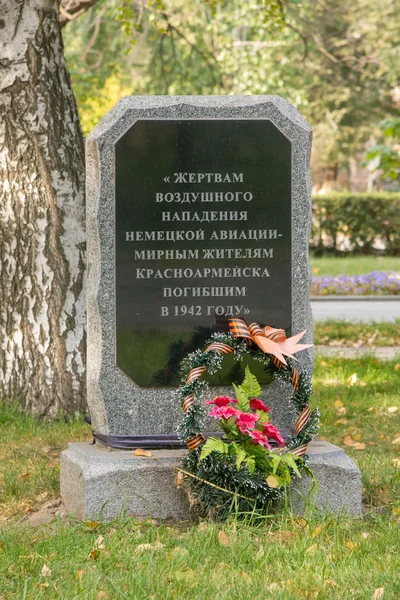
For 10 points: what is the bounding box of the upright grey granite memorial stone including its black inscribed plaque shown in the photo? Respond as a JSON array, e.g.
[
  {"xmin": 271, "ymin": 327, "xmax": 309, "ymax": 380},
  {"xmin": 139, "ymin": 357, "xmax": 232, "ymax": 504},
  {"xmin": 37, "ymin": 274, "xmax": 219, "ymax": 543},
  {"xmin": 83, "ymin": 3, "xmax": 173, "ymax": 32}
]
[{"xmin": 87, "ymin": 96, "xmax": 312, "ymax": 436}]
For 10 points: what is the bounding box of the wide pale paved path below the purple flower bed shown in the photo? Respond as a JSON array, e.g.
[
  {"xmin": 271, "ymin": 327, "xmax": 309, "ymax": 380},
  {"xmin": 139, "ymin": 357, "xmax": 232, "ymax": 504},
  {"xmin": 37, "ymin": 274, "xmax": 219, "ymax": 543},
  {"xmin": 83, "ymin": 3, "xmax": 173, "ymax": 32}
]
[{"xmin": 311, "ymin": 296, "xmax": 400, "ymax": 323}]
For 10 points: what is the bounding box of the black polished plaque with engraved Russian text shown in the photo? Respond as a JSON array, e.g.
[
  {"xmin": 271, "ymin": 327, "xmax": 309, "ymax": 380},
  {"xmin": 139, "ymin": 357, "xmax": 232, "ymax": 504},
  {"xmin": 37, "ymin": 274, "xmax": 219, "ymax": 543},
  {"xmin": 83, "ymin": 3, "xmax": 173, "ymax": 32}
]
[{"xmin": 115, "ymin": 119, "xmax": 292, "ymax": 386}]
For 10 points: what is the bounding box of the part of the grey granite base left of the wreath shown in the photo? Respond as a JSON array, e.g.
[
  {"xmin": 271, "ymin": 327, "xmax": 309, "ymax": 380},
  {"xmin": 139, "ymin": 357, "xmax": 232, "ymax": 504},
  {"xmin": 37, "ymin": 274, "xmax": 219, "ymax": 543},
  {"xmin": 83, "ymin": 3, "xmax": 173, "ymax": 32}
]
[{"xmin": 60, "ymin": 442, "xmax": 189, "ymax": 521}]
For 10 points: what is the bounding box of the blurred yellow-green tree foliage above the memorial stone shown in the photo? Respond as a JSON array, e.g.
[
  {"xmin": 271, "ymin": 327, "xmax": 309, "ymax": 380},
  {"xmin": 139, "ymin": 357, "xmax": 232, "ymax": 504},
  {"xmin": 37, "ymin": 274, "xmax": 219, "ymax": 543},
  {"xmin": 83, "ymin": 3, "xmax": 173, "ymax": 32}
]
[{"xmin": 65, "ymin": 0, "xmax": 400, "ymax": 185}]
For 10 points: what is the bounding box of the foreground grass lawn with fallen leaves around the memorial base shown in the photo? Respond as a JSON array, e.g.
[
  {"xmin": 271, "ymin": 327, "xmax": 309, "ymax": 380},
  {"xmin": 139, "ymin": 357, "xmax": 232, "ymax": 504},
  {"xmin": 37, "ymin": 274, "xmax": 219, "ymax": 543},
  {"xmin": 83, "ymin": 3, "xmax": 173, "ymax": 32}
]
[{"xmin": 0, "ymin": 357, "xmax": 400, "ymax": 600}]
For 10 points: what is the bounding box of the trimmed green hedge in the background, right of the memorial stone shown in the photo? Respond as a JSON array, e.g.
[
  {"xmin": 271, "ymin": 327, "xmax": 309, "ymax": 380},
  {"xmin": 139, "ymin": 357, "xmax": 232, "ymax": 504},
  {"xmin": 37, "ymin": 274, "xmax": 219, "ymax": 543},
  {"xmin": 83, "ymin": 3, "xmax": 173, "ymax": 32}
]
[{"xmin": 310, "ymin": 192, "xmax": 400, "ymax": 256}]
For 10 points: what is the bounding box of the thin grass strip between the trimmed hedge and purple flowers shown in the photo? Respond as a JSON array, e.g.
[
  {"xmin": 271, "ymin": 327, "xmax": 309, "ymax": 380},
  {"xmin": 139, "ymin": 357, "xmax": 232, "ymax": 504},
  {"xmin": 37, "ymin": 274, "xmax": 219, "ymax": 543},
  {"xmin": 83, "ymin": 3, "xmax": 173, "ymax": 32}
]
[{"xmin": 311, "ymin": 256, "xmax": 400, "ymax": 277}]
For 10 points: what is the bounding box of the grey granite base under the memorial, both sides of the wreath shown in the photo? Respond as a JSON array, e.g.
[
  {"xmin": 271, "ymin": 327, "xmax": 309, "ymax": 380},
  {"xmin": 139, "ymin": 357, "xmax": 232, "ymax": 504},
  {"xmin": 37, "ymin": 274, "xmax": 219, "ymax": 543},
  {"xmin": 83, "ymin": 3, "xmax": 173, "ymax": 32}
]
[{"xmin": 61, "ymin": 441, "xmax": 361, "ymax": 521}]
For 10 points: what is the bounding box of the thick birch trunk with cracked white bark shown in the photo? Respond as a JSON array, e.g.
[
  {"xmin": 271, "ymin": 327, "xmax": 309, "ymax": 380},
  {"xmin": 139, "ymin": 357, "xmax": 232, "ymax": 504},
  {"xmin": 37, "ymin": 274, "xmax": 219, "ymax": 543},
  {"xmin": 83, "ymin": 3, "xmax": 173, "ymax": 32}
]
[{"xmin": 0, "ymin": 0, "xmax": 85, "ymax": 415}]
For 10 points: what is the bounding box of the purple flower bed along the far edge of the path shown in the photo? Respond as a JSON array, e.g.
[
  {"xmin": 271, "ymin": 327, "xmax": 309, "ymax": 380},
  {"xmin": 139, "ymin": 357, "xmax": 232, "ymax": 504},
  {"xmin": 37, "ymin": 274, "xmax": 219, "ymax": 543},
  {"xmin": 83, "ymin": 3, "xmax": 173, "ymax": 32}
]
[{"xmin": 311, "ymin": 271, "xmax": 400, "ymax": 296}]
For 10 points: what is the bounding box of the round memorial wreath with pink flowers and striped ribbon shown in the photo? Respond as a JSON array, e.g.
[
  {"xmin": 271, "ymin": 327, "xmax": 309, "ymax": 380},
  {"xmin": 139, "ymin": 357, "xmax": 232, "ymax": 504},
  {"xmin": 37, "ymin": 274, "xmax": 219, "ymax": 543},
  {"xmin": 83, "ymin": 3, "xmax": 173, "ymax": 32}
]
[{"xmin": 176, "ymin": 319, "xmax": 319, "ymax": 518}]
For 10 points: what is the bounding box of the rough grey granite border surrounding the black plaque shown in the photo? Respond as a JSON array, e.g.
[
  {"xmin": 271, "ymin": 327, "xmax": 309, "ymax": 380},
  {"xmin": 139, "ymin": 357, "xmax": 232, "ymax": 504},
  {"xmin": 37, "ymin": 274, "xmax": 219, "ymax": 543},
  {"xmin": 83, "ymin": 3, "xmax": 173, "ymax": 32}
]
[{"xmin": 87, "ymin": 96, "xmax": 313, "ymax": 435}]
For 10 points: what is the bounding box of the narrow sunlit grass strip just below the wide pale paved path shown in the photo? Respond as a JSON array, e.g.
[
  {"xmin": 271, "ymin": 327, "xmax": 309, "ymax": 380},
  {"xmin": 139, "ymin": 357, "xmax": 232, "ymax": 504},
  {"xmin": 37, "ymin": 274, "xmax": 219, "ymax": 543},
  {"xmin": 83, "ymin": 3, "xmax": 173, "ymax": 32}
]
[{"xmin": 314, "ymin": 319, "xmax": 400, "ymax": 348}]
